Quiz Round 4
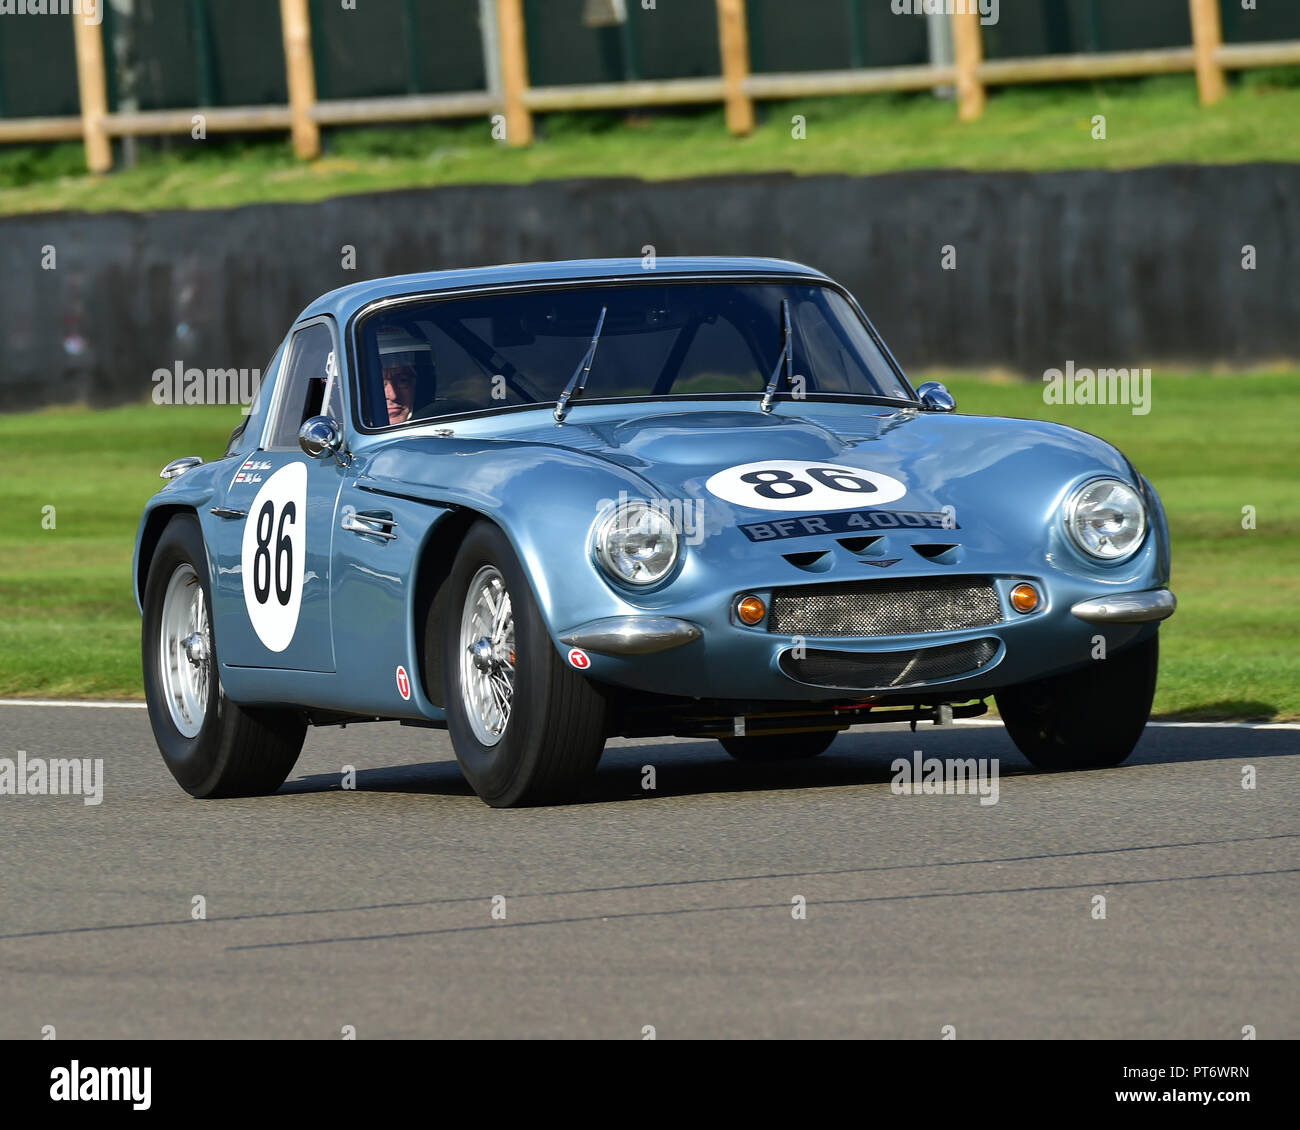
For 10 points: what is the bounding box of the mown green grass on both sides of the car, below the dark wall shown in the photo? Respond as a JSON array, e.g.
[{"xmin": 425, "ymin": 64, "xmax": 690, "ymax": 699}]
[{"xmin": 0, "ymin": 371, "xmax": 1300, "ymax": 719}]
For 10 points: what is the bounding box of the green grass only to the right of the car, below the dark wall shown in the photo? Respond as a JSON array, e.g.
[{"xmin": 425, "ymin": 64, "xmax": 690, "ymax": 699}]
[{"xmin": 937, "ymin": 369, "xmax": 1300, "ymax": 719}]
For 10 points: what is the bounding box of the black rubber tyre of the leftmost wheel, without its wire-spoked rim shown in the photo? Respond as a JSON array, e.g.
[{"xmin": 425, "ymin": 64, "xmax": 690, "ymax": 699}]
[{"xmin": 140, "ymin": 515, "xmax": 307, "ymax": 797}]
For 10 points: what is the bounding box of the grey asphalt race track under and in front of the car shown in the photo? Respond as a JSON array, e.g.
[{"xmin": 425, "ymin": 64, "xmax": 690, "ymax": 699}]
[{"xmin": 0, "ymin": 705, "xmax": 1300, "ymax": 1039}]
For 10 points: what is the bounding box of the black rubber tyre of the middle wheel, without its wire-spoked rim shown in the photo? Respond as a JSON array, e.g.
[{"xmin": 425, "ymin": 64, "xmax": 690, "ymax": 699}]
[{"xmin": 441, "ymin": 521, "xmax": 608, "ymax": 808}]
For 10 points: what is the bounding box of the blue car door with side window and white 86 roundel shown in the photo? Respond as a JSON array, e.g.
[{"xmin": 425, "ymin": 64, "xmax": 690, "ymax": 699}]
[{"xmin": 212, "ymin": 317, "xmax": 346, "ymax": 671}]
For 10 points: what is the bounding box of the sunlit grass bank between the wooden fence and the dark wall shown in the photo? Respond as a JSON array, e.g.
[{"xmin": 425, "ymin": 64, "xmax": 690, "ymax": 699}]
[{"xmin": 0, "ymin": 68, "xmax": 1300, "ymax": 213}]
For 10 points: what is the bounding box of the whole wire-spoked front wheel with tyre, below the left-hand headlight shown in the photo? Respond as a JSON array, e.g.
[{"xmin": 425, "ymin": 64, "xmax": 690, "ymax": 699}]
[{"xmin": 441, "ymin": 521, "xmax": 608, "ymax": 808}]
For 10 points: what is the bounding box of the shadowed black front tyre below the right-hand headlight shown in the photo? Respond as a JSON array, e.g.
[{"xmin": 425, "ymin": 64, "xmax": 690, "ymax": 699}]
[{"xmin": 996, "ymin": 636, "xmax": 1160, "ymax": 772}]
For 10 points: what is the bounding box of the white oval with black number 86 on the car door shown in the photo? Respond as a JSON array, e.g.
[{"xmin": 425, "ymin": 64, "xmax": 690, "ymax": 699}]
[{"xmin": 239, "ymin": 463, "xmax": 307, "ymax": 651}]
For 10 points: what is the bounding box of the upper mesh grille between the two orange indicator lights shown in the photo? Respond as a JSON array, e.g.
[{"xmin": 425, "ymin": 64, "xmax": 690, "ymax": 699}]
[{"xmin": 767, "ymin": 577, "xmax": 1002, "ymax": 636}]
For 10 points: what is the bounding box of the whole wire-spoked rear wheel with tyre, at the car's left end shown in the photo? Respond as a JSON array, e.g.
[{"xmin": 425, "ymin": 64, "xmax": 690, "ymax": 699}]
[{"xmin": 140, "ymin": 515, "xmax": 307, "ymax": 797}]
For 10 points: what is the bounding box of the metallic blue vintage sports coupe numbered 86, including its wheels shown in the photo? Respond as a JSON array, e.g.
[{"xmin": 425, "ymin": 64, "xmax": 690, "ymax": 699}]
[{"xmin": 134, "ymin": 259, "xmax": 1174, "ymax": 806}]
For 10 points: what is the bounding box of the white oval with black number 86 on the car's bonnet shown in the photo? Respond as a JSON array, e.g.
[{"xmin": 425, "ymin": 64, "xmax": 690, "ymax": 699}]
[{"xmin": 705, "ymin": 459, "xmax": 907, "ymax": 511}]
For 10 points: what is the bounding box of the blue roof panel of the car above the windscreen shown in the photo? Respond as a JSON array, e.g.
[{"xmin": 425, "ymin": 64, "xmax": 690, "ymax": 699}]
[{"xmin": 298, "ymin": 256, "xmax": 826, "ymax": 321}]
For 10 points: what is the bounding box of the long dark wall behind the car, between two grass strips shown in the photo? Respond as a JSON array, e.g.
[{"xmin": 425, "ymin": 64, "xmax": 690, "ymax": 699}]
[{"xmin": 0, "ymin": 165, "xmax": 1300, "ymax": 410}]
